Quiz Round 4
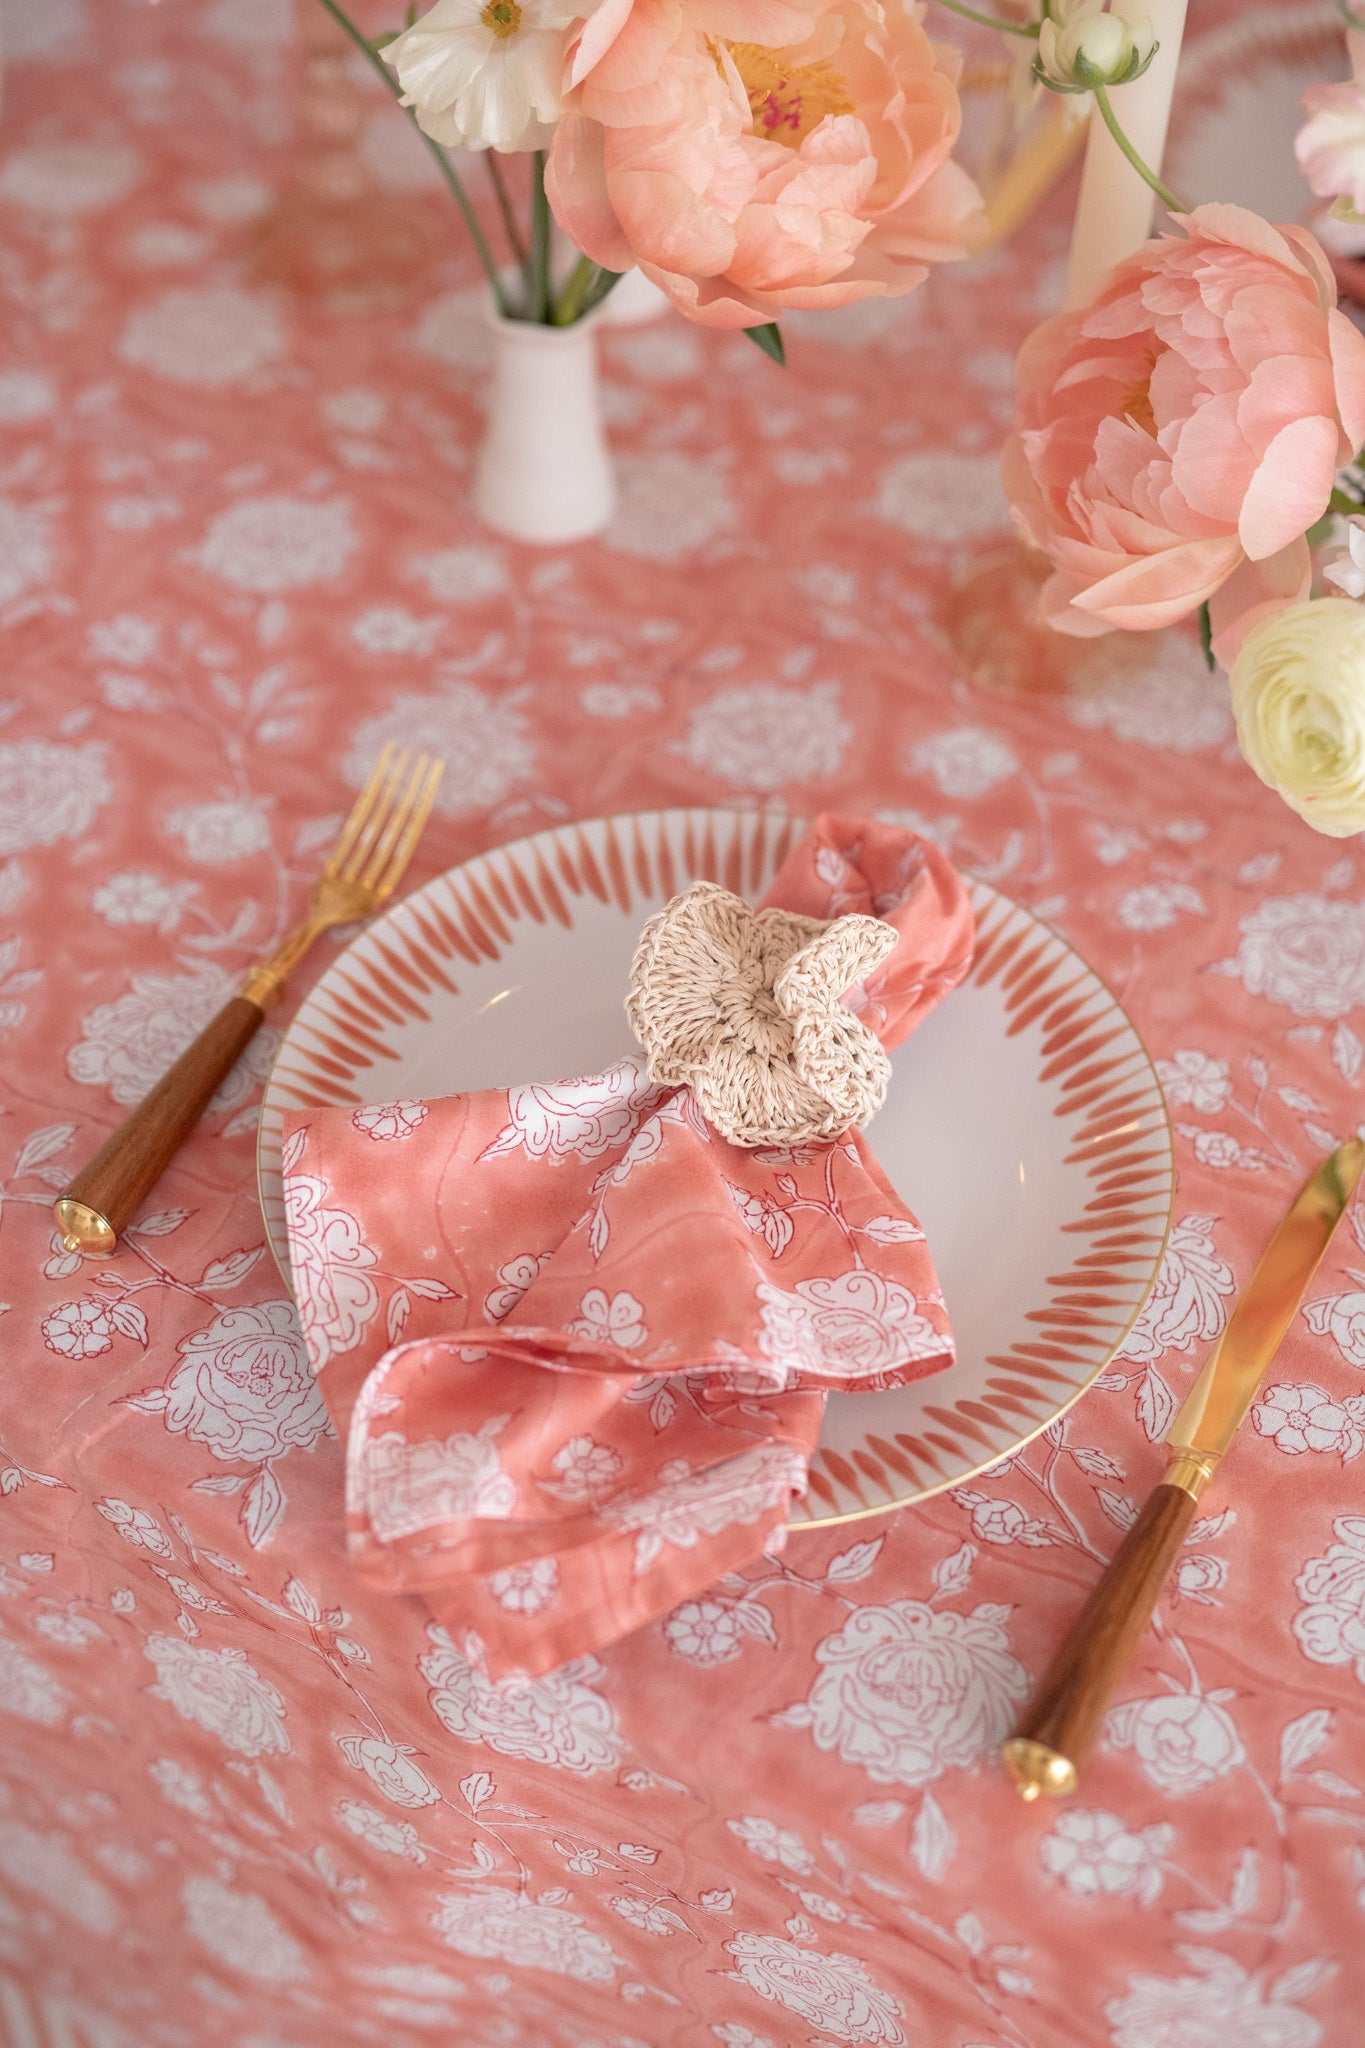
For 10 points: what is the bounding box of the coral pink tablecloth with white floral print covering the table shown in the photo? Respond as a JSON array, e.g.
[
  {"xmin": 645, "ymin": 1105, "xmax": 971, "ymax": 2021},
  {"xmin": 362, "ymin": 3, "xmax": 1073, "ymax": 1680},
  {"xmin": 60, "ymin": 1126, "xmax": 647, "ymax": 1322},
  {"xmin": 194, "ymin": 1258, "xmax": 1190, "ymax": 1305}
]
[{"xmin": 0, "ymin": 0, "xmax": 1365, "ymax": 2048}]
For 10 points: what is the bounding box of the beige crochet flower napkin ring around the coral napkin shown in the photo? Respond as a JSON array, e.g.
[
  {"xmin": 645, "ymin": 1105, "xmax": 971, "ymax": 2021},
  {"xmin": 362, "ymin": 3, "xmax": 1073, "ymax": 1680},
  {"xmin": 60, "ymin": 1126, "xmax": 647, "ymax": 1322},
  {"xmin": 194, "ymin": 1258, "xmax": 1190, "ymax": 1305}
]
[{"xmin": 626, "ymin": 883, "xmax": 898, "ymax": 1147}]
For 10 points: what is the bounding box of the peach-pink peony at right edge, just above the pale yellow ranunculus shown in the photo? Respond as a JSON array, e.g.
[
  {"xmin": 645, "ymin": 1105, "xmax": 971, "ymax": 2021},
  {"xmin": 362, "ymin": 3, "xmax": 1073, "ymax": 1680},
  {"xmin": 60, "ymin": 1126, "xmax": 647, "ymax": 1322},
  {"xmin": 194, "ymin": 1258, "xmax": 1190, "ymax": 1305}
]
[{"xmin": 1005, "ymin": 205, "xmax": 1365, "ymax": 664}]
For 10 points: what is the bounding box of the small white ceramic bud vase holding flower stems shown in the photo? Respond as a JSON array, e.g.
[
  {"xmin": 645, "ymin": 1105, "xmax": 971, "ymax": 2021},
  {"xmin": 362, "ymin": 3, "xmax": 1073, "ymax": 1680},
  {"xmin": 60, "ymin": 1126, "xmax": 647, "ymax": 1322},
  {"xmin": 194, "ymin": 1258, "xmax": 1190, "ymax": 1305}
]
[{"xmin": 473, "ymin": 313, "xmax": 616, "ymax": 547}]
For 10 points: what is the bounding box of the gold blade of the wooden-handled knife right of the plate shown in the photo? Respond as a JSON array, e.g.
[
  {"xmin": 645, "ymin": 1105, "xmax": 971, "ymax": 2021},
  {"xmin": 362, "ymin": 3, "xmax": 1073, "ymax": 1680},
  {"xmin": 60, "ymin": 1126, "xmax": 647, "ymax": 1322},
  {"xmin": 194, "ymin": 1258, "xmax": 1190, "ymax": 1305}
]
[{"xmin": 1166, "ymin": 1139, "xmax": 1365, "ymax": 1499}]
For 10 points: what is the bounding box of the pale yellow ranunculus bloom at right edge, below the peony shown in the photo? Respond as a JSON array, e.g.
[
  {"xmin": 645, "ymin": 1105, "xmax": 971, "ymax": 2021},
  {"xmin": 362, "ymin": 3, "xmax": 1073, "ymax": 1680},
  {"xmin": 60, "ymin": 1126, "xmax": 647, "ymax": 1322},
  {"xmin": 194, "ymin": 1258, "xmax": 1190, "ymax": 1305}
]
[{"xmin": 1230, "ymin": 598, "xmax": 1365, "ymax": 840}]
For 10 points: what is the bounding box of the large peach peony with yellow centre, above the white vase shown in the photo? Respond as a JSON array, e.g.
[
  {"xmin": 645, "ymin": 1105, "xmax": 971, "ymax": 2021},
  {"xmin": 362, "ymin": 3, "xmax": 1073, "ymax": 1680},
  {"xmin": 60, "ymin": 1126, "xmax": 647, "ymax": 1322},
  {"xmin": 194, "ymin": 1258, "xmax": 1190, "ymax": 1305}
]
[{"xmin": 546, "ymin": 0, "xmax": 980, "ymax": 328}]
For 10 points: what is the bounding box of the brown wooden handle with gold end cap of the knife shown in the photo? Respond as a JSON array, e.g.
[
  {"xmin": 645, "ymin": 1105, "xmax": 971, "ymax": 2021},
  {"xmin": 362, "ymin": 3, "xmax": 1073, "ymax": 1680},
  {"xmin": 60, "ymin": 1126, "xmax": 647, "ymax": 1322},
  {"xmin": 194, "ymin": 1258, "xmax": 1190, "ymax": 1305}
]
[{"xmin": 1001, "ymin": 1481, "xmax": 1195, "ymax": 1798}]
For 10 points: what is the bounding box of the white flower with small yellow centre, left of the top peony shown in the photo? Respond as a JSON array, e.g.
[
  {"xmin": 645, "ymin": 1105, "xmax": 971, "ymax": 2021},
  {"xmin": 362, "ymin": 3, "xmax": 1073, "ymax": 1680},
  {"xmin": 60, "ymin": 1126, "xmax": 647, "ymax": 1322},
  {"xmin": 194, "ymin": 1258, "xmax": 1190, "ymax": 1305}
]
[{"xmin": 383, "ymin": 0, "xmax": 581, "ymax": 150}]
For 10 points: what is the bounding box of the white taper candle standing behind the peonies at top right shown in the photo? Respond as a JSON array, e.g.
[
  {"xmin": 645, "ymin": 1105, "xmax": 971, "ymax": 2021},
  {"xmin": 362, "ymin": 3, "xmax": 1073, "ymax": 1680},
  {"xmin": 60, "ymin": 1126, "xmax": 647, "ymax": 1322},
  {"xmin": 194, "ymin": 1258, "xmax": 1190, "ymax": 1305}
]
[{"xmin": 1066, "ymin": 0, "xmax": 1187, "ymax": 305}]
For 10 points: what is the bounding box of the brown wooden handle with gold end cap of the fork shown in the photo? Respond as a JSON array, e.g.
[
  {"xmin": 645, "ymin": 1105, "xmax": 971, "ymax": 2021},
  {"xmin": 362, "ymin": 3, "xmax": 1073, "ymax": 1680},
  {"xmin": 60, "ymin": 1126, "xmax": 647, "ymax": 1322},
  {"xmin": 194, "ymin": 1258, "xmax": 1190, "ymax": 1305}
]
[{"xmin": 55, "ymin": 995, "xmax": 266, "ymax": 1251}]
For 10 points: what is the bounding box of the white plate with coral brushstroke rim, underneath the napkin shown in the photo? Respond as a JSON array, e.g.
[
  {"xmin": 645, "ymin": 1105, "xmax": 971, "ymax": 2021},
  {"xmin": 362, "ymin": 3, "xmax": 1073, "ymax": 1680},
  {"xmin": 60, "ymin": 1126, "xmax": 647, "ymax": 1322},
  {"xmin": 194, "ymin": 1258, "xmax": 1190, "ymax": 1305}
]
[{"xmin": 258, "ymin": 811, "xmax": 1173, "ymax": 1526}]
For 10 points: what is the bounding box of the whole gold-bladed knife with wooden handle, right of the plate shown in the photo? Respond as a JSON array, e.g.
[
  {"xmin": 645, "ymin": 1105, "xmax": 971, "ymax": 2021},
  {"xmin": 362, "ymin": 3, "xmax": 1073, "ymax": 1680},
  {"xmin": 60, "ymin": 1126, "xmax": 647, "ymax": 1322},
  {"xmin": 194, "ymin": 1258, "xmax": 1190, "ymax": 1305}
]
[{"xmin": 1001, "ymin": 1139, "xmax": 1365, "ymax": 1800}]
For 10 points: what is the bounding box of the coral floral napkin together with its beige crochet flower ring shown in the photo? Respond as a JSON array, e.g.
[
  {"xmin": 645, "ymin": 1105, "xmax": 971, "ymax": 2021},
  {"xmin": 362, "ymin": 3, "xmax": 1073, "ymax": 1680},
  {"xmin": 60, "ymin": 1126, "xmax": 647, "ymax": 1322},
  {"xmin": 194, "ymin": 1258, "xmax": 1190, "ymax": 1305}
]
[{"xmin": 284, "ymin": 815, "xmax": 974, "ymax": 1677}]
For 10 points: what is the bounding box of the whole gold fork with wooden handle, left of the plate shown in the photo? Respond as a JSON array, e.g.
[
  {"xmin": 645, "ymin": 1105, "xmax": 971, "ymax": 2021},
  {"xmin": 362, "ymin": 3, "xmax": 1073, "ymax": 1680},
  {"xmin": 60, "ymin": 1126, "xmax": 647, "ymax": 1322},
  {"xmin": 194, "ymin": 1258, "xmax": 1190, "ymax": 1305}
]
[{"xmin": 53, "ymin": 745, "xmax": 444, "ymax": 1251}]
